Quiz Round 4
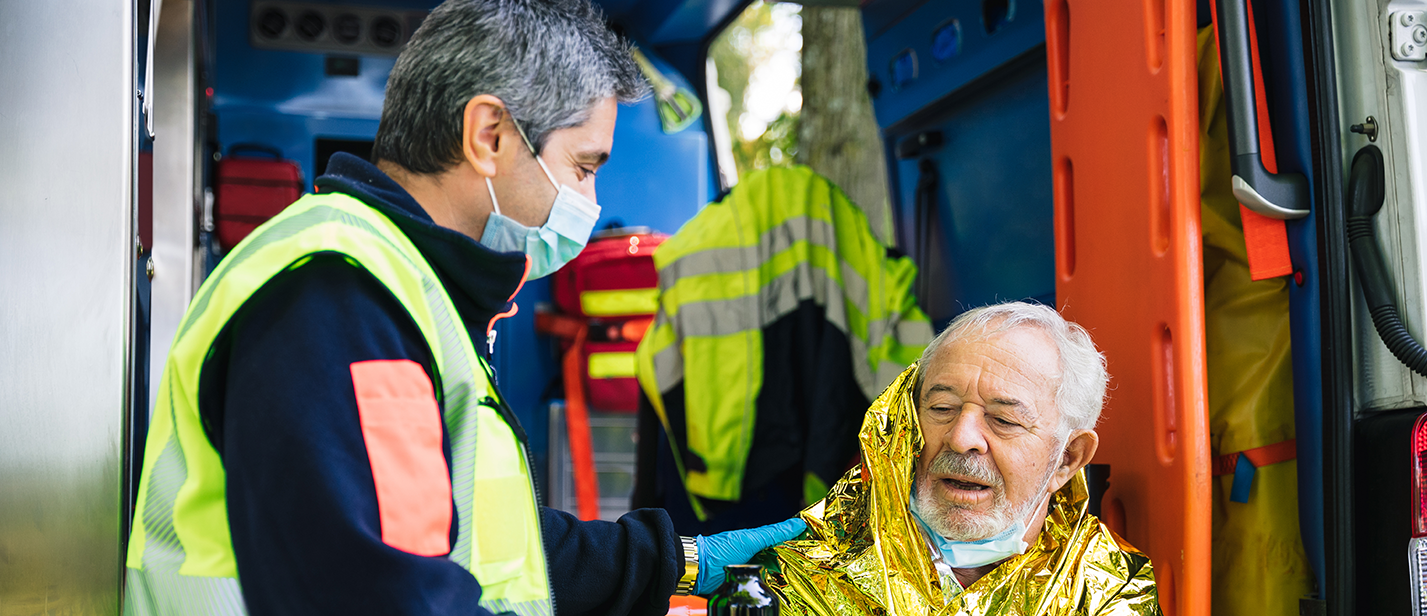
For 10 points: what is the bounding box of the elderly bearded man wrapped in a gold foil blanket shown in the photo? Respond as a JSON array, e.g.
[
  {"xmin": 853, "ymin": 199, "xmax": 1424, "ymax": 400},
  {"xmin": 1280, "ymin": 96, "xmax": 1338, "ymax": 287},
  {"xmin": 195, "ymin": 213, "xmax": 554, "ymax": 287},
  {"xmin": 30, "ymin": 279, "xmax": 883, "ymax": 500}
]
[{"xmin": 763, "ymin": 302, "xmax": 1160, "ymax": 616}]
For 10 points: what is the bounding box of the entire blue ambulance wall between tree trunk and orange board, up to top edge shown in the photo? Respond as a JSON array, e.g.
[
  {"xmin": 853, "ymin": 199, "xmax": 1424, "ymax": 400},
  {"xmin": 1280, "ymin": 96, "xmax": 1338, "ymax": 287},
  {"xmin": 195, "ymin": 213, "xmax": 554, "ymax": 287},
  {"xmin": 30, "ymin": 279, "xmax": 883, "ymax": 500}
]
[{"xmin": 863, "ymin": 0, "xmax": 1055, "ymax": 327}]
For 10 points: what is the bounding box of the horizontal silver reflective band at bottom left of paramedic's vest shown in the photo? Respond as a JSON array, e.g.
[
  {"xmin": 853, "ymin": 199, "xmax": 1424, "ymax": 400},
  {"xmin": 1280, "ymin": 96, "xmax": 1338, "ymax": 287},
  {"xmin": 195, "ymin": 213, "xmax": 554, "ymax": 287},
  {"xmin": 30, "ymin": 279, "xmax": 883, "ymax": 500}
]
[{"xmin": 124, "ymin": 567, "xmax": 248, "ymax": 616}]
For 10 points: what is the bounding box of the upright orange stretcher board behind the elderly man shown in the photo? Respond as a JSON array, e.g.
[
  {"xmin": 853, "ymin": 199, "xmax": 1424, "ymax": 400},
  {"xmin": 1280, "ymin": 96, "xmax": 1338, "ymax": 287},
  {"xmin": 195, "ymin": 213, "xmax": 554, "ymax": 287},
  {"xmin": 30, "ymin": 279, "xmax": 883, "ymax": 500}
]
[{"xmin": 1046, "ymin": 0, "xmax": 1212, "ymax": 616}]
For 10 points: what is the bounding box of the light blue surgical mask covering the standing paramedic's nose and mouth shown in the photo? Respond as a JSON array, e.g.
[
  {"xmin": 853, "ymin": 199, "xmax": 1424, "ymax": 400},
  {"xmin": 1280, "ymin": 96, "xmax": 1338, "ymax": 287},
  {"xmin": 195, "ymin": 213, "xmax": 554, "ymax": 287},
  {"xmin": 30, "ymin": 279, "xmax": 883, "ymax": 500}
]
[{"xmin": 481, "ymin": 118, "xmax": 599, "ymax": 279}]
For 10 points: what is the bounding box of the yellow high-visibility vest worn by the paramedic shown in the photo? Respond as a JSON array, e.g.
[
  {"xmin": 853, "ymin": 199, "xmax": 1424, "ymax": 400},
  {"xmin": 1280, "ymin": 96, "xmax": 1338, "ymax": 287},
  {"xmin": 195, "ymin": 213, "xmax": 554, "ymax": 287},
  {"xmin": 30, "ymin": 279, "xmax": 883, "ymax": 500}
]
[{"xmin": 124, "ymin": 193, "xmax": 552, "ymax": 616}]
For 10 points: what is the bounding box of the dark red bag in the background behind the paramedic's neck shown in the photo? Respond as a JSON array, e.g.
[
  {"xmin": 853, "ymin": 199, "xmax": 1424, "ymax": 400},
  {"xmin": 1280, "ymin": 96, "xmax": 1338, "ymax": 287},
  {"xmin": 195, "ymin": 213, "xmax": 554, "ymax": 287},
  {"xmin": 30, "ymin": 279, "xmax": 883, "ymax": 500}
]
[{"xmin": 213, "ymin": 144, "xmax": 303, "ymax": 250}]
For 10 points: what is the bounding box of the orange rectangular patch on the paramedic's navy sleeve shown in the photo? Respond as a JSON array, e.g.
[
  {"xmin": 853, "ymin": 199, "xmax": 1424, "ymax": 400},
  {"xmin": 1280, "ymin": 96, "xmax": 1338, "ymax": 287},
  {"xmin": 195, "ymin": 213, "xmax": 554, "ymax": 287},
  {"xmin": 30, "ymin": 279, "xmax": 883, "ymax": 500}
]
[{"xmin": 351, "ymin": 359, "xmax": 451, "ymax": 556}]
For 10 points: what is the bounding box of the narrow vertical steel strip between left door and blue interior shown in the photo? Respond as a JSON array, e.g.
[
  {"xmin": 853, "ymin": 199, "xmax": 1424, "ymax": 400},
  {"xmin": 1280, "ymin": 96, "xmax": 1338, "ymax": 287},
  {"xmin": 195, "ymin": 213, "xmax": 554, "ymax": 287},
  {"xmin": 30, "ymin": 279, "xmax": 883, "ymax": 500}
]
[{"xmin": 146, "ymin": 0, "xmax": 203, "ymax": 412}]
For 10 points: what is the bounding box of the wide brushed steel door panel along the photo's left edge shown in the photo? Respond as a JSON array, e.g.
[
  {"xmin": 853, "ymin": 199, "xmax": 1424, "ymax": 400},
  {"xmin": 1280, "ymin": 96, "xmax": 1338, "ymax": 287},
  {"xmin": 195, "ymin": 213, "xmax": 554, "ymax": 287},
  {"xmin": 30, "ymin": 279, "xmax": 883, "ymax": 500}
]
[{"xmin": 0, "ymin": 0, "xmax": 137, "ymax": 615}]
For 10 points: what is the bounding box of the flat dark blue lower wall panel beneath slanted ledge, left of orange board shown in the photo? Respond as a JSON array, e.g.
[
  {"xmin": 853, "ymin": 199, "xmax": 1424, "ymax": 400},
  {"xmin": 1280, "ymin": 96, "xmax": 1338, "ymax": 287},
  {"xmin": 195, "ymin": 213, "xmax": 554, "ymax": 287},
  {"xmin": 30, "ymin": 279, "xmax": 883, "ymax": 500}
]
[{"xmin": 888, "ymin": 61, "xmax": 1056, "ymax": 327}]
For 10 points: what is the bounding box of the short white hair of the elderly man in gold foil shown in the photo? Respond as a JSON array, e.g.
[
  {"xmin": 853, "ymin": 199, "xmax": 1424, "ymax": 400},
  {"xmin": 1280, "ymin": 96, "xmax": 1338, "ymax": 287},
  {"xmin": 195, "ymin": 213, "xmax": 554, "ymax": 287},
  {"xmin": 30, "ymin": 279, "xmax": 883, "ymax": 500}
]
[{"xmin": 916, "ymin": 302, "xmax": 1109, "ymax": 438}]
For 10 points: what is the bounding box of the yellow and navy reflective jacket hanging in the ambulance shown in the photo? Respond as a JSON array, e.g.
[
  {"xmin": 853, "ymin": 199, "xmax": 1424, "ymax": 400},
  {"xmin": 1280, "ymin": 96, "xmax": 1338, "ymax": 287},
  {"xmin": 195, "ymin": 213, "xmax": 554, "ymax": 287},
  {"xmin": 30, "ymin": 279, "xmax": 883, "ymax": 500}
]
[{"xmin": 635, "ymin": 167, "xmax": 932, "ymax": 519}]
